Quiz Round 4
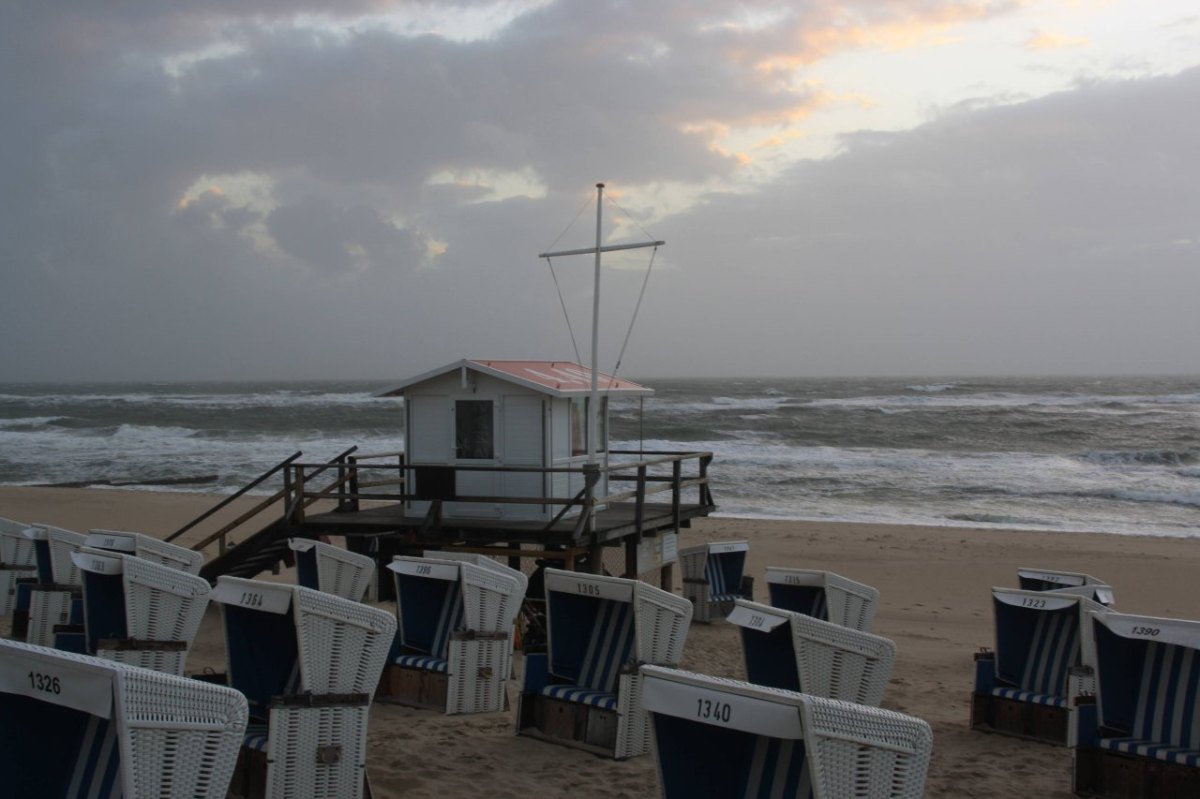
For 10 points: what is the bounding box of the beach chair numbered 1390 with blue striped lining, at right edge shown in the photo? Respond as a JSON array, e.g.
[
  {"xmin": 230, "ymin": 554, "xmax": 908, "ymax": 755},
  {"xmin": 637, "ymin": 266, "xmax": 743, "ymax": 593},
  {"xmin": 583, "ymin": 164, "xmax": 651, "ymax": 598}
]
[{"xmin": 1070, "ymin": 609, "xmax": 1200, "ymax": 799}]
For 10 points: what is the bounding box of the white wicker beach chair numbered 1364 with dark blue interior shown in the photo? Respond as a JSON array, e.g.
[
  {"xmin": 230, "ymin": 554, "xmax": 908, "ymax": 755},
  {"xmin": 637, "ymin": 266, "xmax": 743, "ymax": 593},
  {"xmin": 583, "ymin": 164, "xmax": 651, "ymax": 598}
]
[{"xmin": 211, "ymin": 576, "xmax": 396, "ymax": 799}]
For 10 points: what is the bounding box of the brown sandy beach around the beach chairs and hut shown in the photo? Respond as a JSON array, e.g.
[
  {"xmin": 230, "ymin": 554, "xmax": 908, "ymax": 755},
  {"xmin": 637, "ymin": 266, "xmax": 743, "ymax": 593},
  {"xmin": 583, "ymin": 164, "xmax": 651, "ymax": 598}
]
[{"xmin": 0, "ymin": 487, "xmax": 1200, "ymax": 799}]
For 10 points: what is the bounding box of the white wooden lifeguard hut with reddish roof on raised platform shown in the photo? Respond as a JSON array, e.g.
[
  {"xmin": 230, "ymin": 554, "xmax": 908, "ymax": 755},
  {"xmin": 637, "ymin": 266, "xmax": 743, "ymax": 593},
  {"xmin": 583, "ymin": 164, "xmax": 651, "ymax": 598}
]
[{"xmin": 384, "ymin": 360, "xmax": 654, "ymax": 521}]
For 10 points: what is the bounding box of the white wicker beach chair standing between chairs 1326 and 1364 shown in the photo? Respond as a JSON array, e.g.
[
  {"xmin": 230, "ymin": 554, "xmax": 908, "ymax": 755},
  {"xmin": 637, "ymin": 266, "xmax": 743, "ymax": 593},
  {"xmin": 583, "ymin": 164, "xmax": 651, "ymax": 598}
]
[{"xmin": 56, "ymin": 547, "xmax": 211, "ymax": 675}]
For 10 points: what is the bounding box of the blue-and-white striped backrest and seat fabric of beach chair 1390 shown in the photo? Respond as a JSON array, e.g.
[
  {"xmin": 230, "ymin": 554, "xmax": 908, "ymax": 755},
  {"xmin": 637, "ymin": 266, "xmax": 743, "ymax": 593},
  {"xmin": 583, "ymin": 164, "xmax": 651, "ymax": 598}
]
[{"xmin": 1100, "ymin": 642, "xmax": 1200, "ymax": 765}]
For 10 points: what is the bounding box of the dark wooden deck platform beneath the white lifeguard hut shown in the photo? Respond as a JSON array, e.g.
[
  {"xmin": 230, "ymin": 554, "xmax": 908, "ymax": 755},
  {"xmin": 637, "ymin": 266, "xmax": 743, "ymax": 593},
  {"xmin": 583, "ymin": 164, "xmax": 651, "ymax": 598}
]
[{"xmin": 304, "ymin": 503, "xmax": 715, "ymax": 547}]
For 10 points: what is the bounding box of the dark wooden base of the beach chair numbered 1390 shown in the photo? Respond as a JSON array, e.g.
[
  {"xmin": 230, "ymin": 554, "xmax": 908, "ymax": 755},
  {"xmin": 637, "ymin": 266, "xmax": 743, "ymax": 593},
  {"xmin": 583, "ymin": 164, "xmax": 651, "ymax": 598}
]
[{"xmin": 1073, "ymin": 749, "xmax": 1200, "ymax": 799}]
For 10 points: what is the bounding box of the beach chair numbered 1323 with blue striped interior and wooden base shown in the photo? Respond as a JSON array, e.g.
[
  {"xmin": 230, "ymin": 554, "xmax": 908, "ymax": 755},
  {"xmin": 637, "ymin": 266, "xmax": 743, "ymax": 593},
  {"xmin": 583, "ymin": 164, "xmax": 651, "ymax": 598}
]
[{"xmin": 971, "ymin": 588, "xmax": 1104, "ymax": 744}]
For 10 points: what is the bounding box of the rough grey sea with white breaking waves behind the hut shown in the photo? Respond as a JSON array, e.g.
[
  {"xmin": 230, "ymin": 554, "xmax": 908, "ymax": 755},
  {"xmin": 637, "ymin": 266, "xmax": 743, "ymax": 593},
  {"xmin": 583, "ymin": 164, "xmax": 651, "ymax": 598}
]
[{"xmin": 0, "ymin": 377, "xmax": 1200, "ymax": 537}]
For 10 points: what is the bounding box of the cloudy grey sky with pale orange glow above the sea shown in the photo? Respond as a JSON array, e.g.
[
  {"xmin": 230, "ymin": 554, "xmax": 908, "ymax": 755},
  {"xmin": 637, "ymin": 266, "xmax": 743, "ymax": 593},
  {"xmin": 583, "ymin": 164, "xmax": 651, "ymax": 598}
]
[{"xmin": 0, "ymin": 0, "xmax": 1200, "ymax": 383}]
